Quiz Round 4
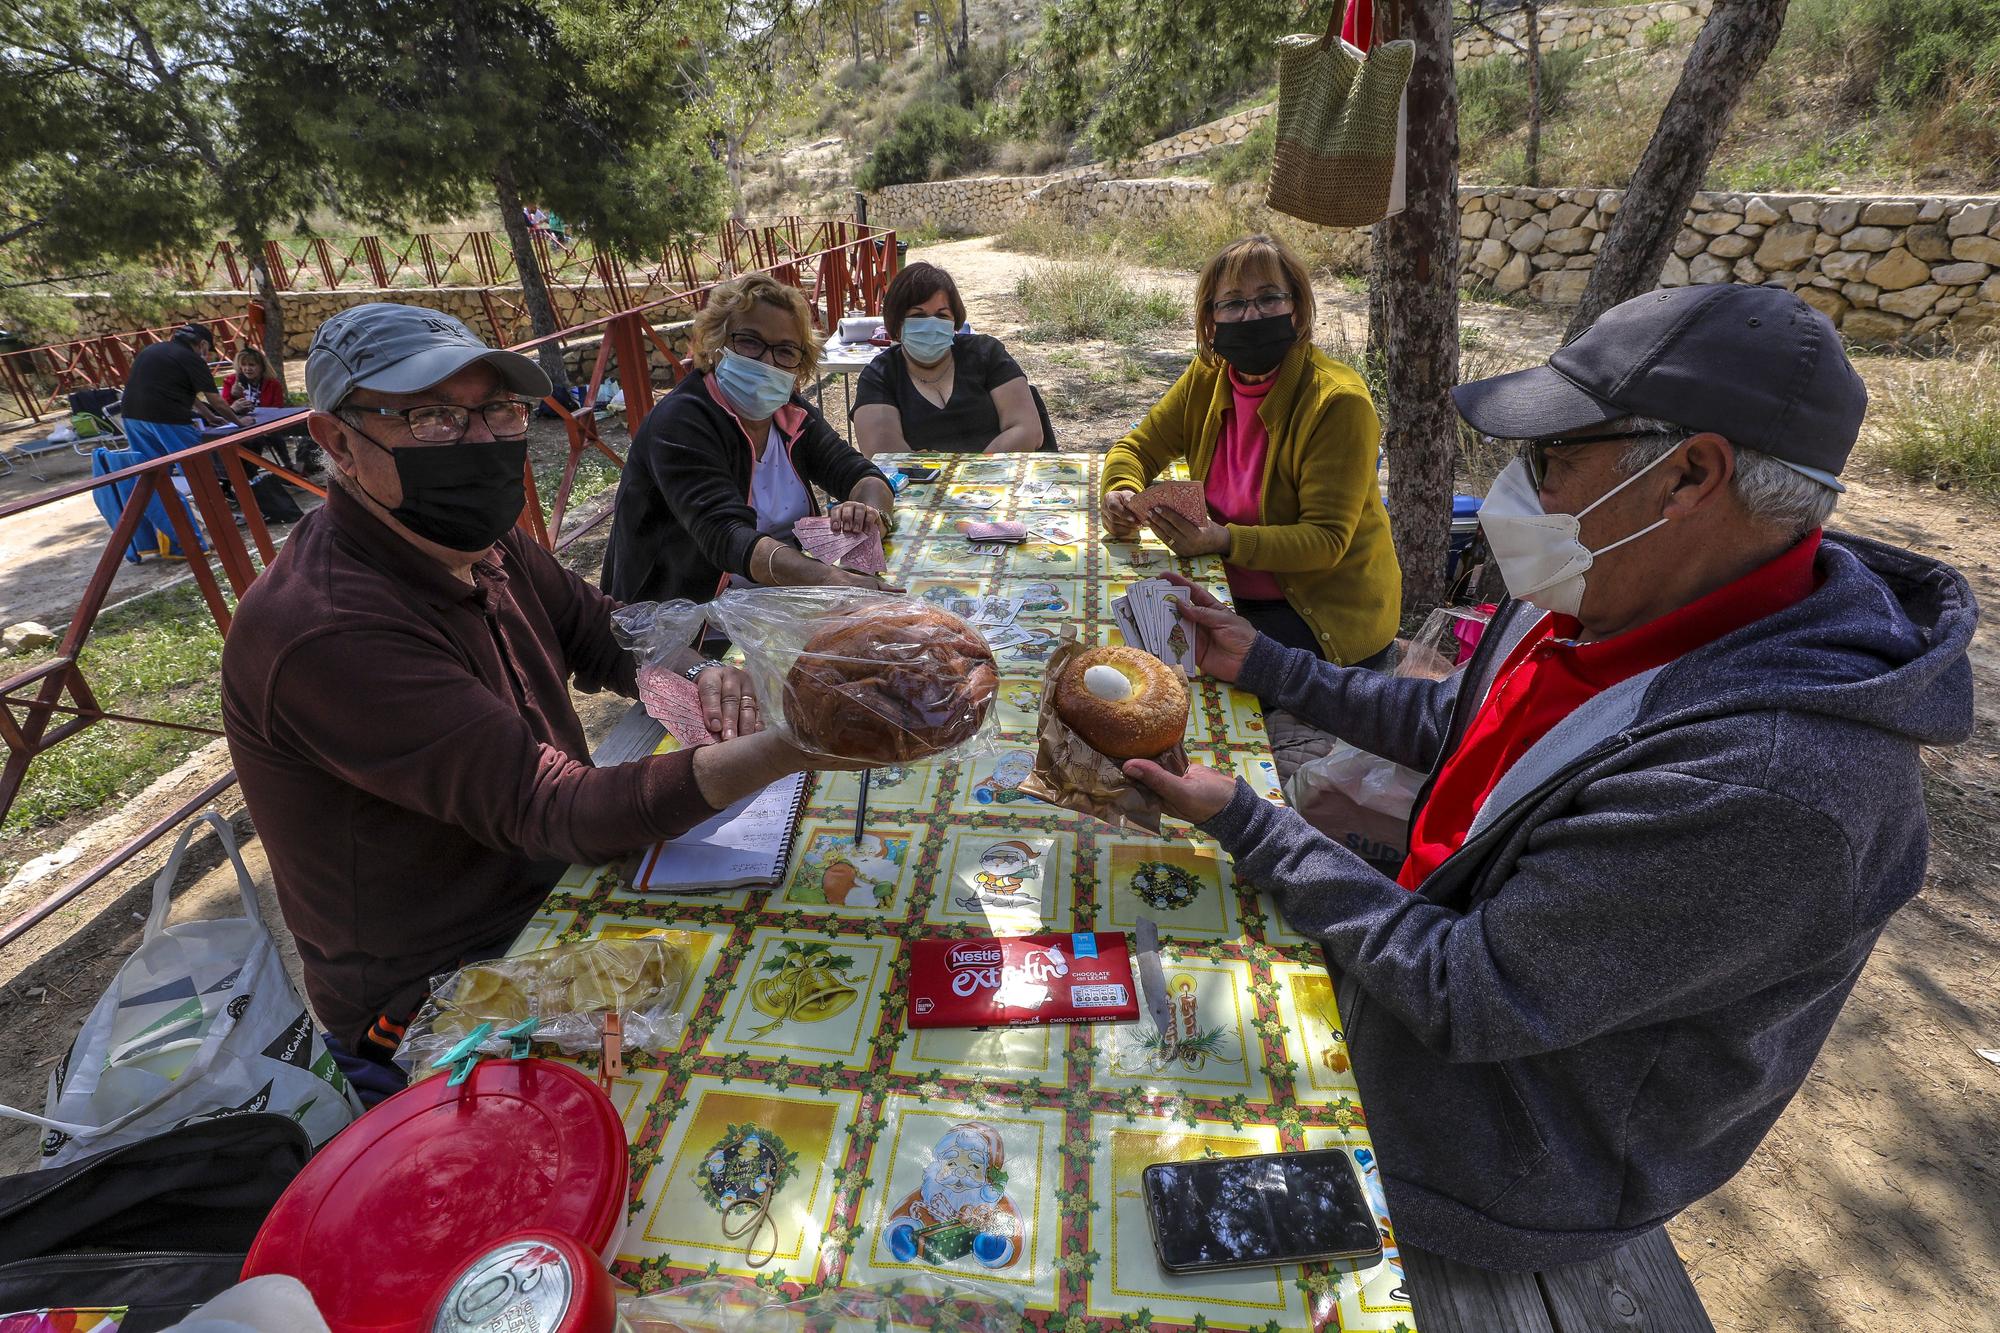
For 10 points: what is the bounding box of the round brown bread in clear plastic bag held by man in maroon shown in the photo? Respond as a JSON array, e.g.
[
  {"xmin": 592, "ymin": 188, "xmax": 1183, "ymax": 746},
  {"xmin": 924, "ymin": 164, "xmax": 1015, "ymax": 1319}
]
[{"xmin": 708, "ymin": 588, "xmax": 1000, "ymax": 765}]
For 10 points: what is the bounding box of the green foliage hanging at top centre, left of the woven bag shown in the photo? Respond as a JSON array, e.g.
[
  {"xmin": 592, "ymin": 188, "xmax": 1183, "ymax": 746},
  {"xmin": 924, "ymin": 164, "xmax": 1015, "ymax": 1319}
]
[{"xmin": 1020, "ymin": 0, "xmax": 1332, "ymax": 156}]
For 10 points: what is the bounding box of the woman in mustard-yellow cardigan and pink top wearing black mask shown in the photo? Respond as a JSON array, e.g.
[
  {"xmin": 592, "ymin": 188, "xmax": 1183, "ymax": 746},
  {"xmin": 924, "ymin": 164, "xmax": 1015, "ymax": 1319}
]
[{"xmin": 1104, "ymin": 236, "xmax": 1402, "ymax": 669}]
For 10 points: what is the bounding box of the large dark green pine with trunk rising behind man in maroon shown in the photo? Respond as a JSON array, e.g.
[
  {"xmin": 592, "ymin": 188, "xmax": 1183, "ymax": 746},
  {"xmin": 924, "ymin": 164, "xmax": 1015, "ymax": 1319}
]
[{"xmin": 240, "ymin": 0, "xmax": 726, "ymax": 384}]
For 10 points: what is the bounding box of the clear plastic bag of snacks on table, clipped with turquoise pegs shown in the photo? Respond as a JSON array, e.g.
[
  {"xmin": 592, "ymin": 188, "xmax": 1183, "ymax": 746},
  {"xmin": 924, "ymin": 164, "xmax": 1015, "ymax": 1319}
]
[{"xmin": 396, "ymin": 931, "xmax": 694, "ymax": 1079}]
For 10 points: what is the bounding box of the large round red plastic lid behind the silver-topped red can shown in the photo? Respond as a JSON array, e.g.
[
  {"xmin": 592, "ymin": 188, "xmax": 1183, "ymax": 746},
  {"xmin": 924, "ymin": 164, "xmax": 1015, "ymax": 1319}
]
[{"xmin": 244, "ymin": 1059, "xmax": 628, "ymax": 1333}]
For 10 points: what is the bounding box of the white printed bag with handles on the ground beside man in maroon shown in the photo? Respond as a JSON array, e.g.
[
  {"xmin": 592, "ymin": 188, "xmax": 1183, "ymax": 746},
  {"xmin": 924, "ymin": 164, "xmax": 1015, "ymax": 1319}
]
[{"xmin": 0, "ymin": 811, "xmax": 360, "ymax": 1167}]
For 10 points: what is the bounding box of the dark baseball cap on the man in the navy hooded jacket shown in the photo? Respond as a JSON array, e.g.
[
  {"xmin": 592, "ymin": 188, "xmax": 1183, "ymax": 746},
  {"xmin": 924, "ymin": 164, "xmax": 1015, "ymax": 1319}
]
[{"xmin": 1452, "ymin": 284, "xmax": 1868, "ymax": 490}]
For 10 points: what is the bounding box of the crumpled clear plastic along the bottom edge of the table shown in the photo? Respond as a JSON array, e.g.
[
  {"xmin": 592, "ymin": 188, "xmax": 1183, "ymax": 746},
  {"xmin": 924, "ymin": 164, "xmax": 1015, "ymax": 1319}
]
[{"xmin": 618, "ymin": 1273, "xmax": 1022, "ymax": 1333}]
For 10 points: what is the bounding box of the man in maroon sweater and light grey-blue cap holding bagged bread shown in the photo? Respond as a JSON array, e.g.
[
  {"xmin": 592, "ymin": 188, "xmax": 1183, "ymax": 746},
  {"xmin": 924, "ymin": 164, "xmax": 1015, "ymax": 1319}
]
[{"xmin": 222, "ymin": 304, "xmax": 860, "ymax": 1099}]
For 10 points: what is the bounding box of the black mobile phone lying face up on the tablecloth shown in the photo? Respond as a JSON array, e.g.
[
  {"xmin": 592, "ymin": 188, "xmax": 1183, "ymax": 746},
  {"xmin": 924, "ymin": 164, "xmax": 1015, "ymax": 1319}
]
[{"xmin": 1144, "ymin": 1149, "xmax": 1382, "ymax": 1273}]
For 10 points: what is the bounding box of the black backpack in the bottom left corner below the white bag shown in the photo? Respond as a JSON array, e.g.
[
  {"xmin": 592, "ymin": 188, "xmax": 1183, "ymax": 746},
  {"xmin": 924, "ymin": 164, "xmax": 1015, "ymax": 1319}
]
[{"xmin": 0, "ymin": 1113, "xmax": 312, "ymax": 1333}]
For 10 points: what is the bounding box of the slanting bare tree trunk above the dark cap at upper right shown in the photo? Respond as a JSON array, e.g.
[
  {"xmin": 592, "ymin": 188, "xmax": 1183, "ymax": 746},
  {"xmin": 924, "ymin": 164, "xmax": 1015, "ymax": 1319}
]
[{"xmin": 1568, "ymin": 0, "xmax": 1788, "ymax": 338}]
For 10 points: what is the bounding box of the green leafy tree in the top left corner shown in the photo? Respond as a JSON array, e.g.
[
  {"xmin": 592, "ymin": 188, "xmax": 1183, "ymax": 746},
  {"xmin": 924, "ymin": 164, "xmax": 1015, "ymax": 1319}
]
[{"xmin": 0, "ymin": 0, "xmax": 318, "ymax": 350}]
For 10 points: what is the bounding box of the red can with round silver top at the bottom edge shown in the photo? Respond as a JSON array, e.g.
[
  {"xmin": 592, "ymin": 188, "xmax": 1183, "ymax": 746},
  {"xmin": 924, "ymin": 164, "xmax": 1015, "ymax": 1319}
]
[{"xmin": 430, "ymin": 1235, "xmax": 614, "ymax": 1333}]
